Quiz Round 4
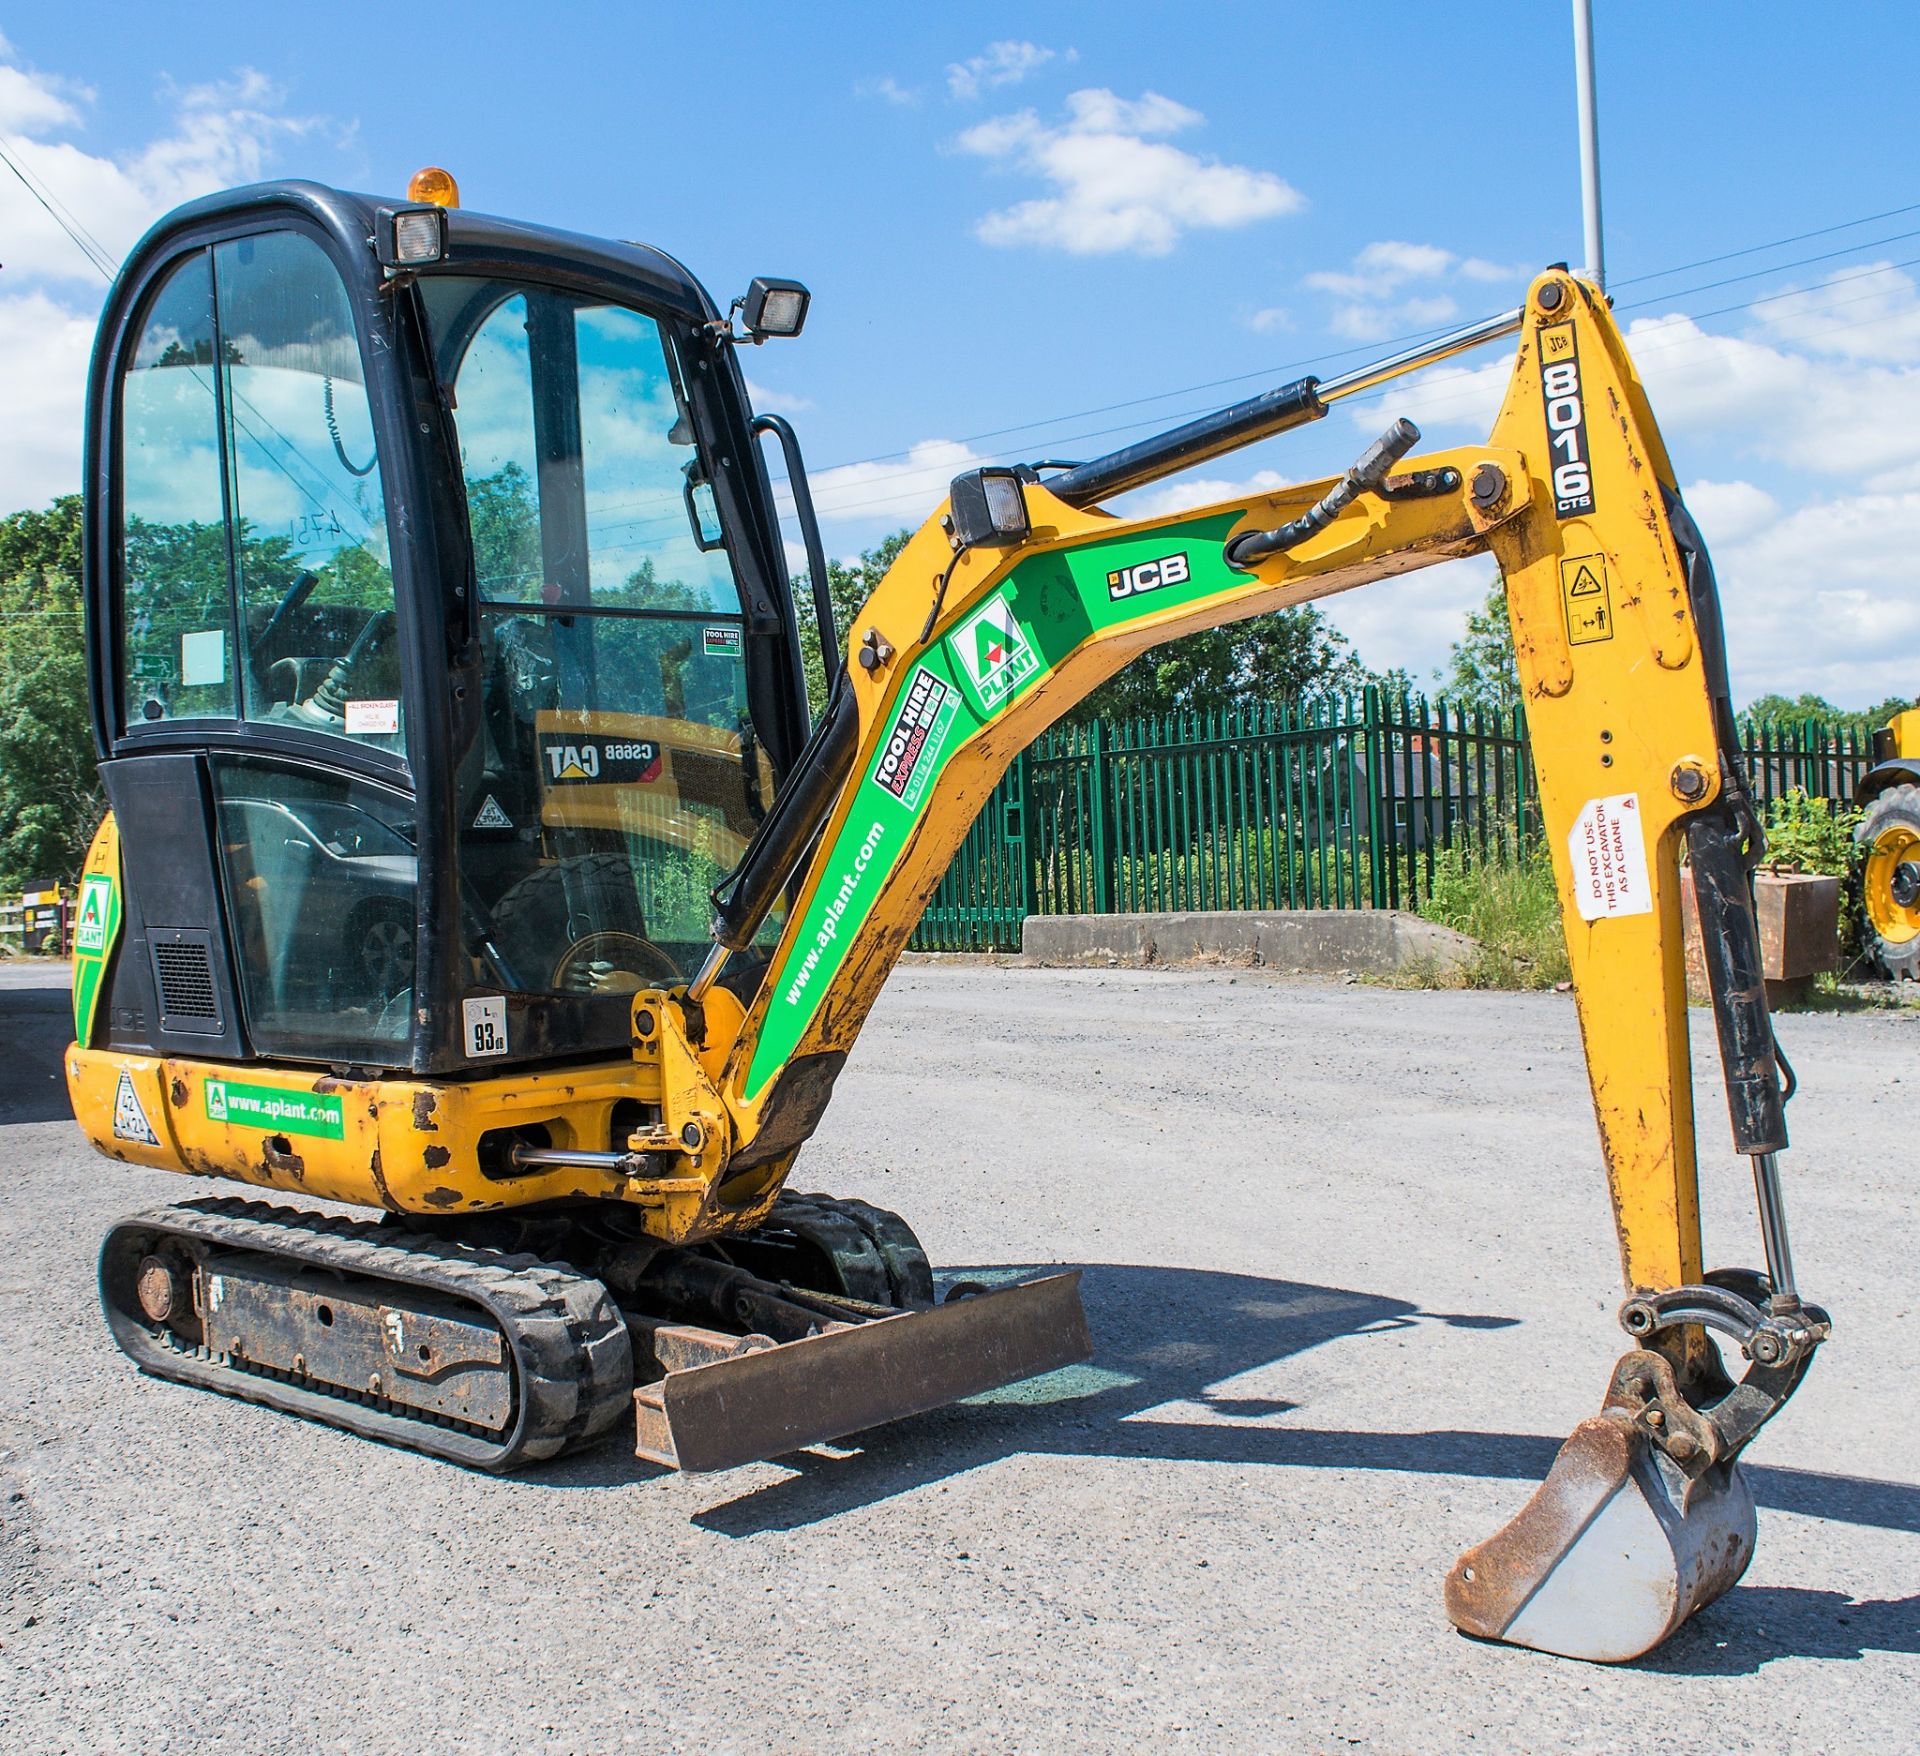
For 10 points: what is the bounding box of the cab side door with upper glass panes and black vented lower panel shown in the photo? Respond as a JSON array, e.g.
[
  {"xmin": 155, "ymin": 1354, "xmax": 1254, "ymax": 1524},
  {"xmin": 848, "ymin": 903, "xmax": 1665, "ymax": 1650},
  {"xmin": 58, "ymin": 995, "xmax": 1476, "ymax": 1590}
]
[{"xmin": 96, "ymin": 221, "xmax": 420, "ymax": 1067}]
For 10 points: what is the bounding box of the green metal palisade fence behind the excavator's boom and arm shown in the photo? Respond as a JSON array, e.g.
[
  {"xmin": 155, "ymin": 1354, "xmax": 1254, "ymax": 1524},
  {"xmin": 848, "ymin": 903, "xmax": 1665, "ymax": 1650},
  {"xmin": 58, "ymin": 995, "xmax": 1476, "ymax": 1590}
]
[{"xmin": 912, "ymin": 689, "xmax": 1872, "ymax": 952}]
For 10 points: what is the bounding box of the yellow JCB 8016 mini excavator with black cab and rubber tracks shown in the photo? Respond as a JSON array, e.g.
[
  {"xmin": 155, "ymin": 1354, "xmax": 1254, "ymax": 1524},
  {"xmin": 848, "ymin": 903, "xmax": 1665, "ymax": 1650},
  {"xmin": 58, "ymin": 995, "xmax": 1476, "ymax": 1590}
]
[{"xmin": 67, "ymin": 173, "xmax": 1828, "ymax": 1660}]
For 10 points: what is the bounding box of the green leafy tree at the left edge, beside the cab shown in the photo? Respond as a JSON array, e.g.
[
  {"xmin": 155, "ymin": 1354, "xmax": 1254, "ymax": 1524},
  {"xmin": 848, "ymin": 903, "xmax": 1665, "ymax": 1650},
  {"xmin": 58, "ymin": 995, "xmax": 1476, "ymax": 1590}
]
[{"xmin": 0, "ymin": 495, "xmax": 104, "ymax": 889}]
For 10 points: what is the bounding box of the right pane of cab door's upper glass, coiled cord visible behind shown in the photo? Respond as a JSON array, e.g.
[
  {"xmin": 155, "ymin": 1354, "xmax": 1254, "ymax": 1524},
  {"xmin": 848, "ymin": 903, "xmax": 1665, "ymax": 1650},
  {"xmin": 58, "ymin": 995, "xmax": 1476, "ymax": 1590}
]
[{"xmin": 213, "ymin": 232, "xmax": 405, "ymax": 750}]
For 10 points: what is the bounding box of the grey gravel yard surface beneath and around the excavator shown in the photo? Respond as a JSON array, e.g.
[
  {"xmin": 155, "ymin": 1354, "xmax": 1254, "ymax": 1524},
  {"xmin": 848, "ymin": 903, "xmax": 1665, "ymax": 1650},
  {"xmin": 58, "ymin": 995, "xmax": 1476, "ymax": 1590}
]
[{"xmin": 0, "ymin": 967, "xmax": 1920, "ymax": 1756}]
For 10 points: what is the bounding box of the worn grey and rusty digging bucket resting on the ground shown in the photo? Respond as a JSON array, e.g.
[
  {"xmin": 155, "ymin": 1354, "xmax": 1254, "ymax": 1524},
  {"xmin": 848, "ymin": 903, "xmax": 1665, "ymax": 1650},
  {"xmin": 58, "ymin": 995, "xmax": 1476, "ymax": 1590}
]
[{"xmin": 1446, "ymin": 1411, "xmax": 1753, "ymax": 1664}]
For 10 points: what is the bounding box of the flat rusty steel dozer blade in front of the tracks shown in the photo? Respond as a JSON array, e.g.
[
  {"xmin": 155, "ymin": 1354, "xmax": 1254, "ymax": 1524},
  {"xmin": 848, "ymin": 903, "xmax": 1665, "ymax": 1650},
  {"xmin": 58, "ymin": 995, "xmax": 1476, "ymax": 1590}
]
[{"xmin": 634, "ymin": 1269, "xmax": 1092, "ymax": 1470}]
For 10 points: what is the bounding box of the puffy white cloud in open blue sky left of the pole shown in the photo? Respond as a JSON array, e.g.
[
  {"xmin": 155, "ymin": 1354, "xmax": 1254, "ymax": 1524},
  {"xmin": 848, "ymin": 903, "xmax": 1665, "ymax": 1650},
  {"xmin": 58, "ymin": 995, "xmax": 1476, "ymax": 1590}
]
[{"xmin": 956, "ymin": 90, "xmax": 1306, "ymax": 255}]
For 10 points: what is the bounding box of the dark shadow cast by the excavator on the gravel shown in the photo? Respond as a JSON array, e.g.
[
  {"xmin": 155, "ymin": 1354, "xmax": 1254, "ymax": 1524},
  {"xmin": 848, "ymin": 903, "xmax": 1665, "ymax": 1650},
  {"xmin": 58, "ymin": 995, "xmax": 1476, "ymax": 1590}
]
[{"xmin": 530, "ymin": 1263, "xmax": 1920, "ymax": 1675}]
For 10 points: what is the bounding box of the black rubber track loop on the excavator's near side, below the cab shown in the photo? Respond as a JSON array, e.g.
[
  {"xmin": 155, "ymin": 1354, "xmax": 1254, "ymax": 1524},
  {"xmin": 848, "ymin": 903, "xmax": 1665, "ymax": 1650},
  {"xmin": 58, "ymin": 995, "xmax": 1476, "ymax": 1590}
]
[{"xmin": 102, "ymin": 1199, "xmax": 634, "ymax": 1474}]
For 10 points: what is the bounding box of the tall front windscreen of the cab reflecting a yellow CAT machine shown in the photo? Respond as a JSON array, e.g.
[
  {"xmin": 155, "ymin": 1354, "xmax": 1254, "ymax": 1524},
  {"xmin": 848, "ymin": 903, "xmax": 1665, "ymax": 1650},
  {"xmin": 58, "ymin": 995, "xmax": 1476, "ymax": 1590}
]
[{"xmin": 420, "ymin": 276, "xmax": 778, "ymax": 994}]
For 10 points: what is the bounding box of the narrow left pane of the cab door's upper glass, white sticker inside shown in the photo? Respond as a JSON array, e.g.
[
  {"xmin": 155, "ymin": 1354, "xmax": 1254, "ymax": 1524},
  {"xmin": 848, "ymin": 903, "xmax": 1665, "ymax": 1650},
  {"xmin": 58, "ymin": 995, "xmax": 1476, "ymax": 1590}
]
[{"xmin": 119, "ymin": 251, "xmax": 234, "ymax": 725}]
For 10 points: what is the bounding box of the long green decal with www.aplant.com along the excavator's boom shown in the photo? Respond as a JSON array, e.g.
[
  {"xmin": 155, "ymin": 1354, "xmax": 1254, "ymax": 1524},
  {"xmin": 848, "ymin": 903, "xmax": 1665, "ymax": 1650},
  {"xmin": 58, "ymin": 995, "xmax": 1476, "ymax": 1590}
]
[{"xmin": 747, "ymin": 512, "xmax": 1246, "ymax": 1098}]
